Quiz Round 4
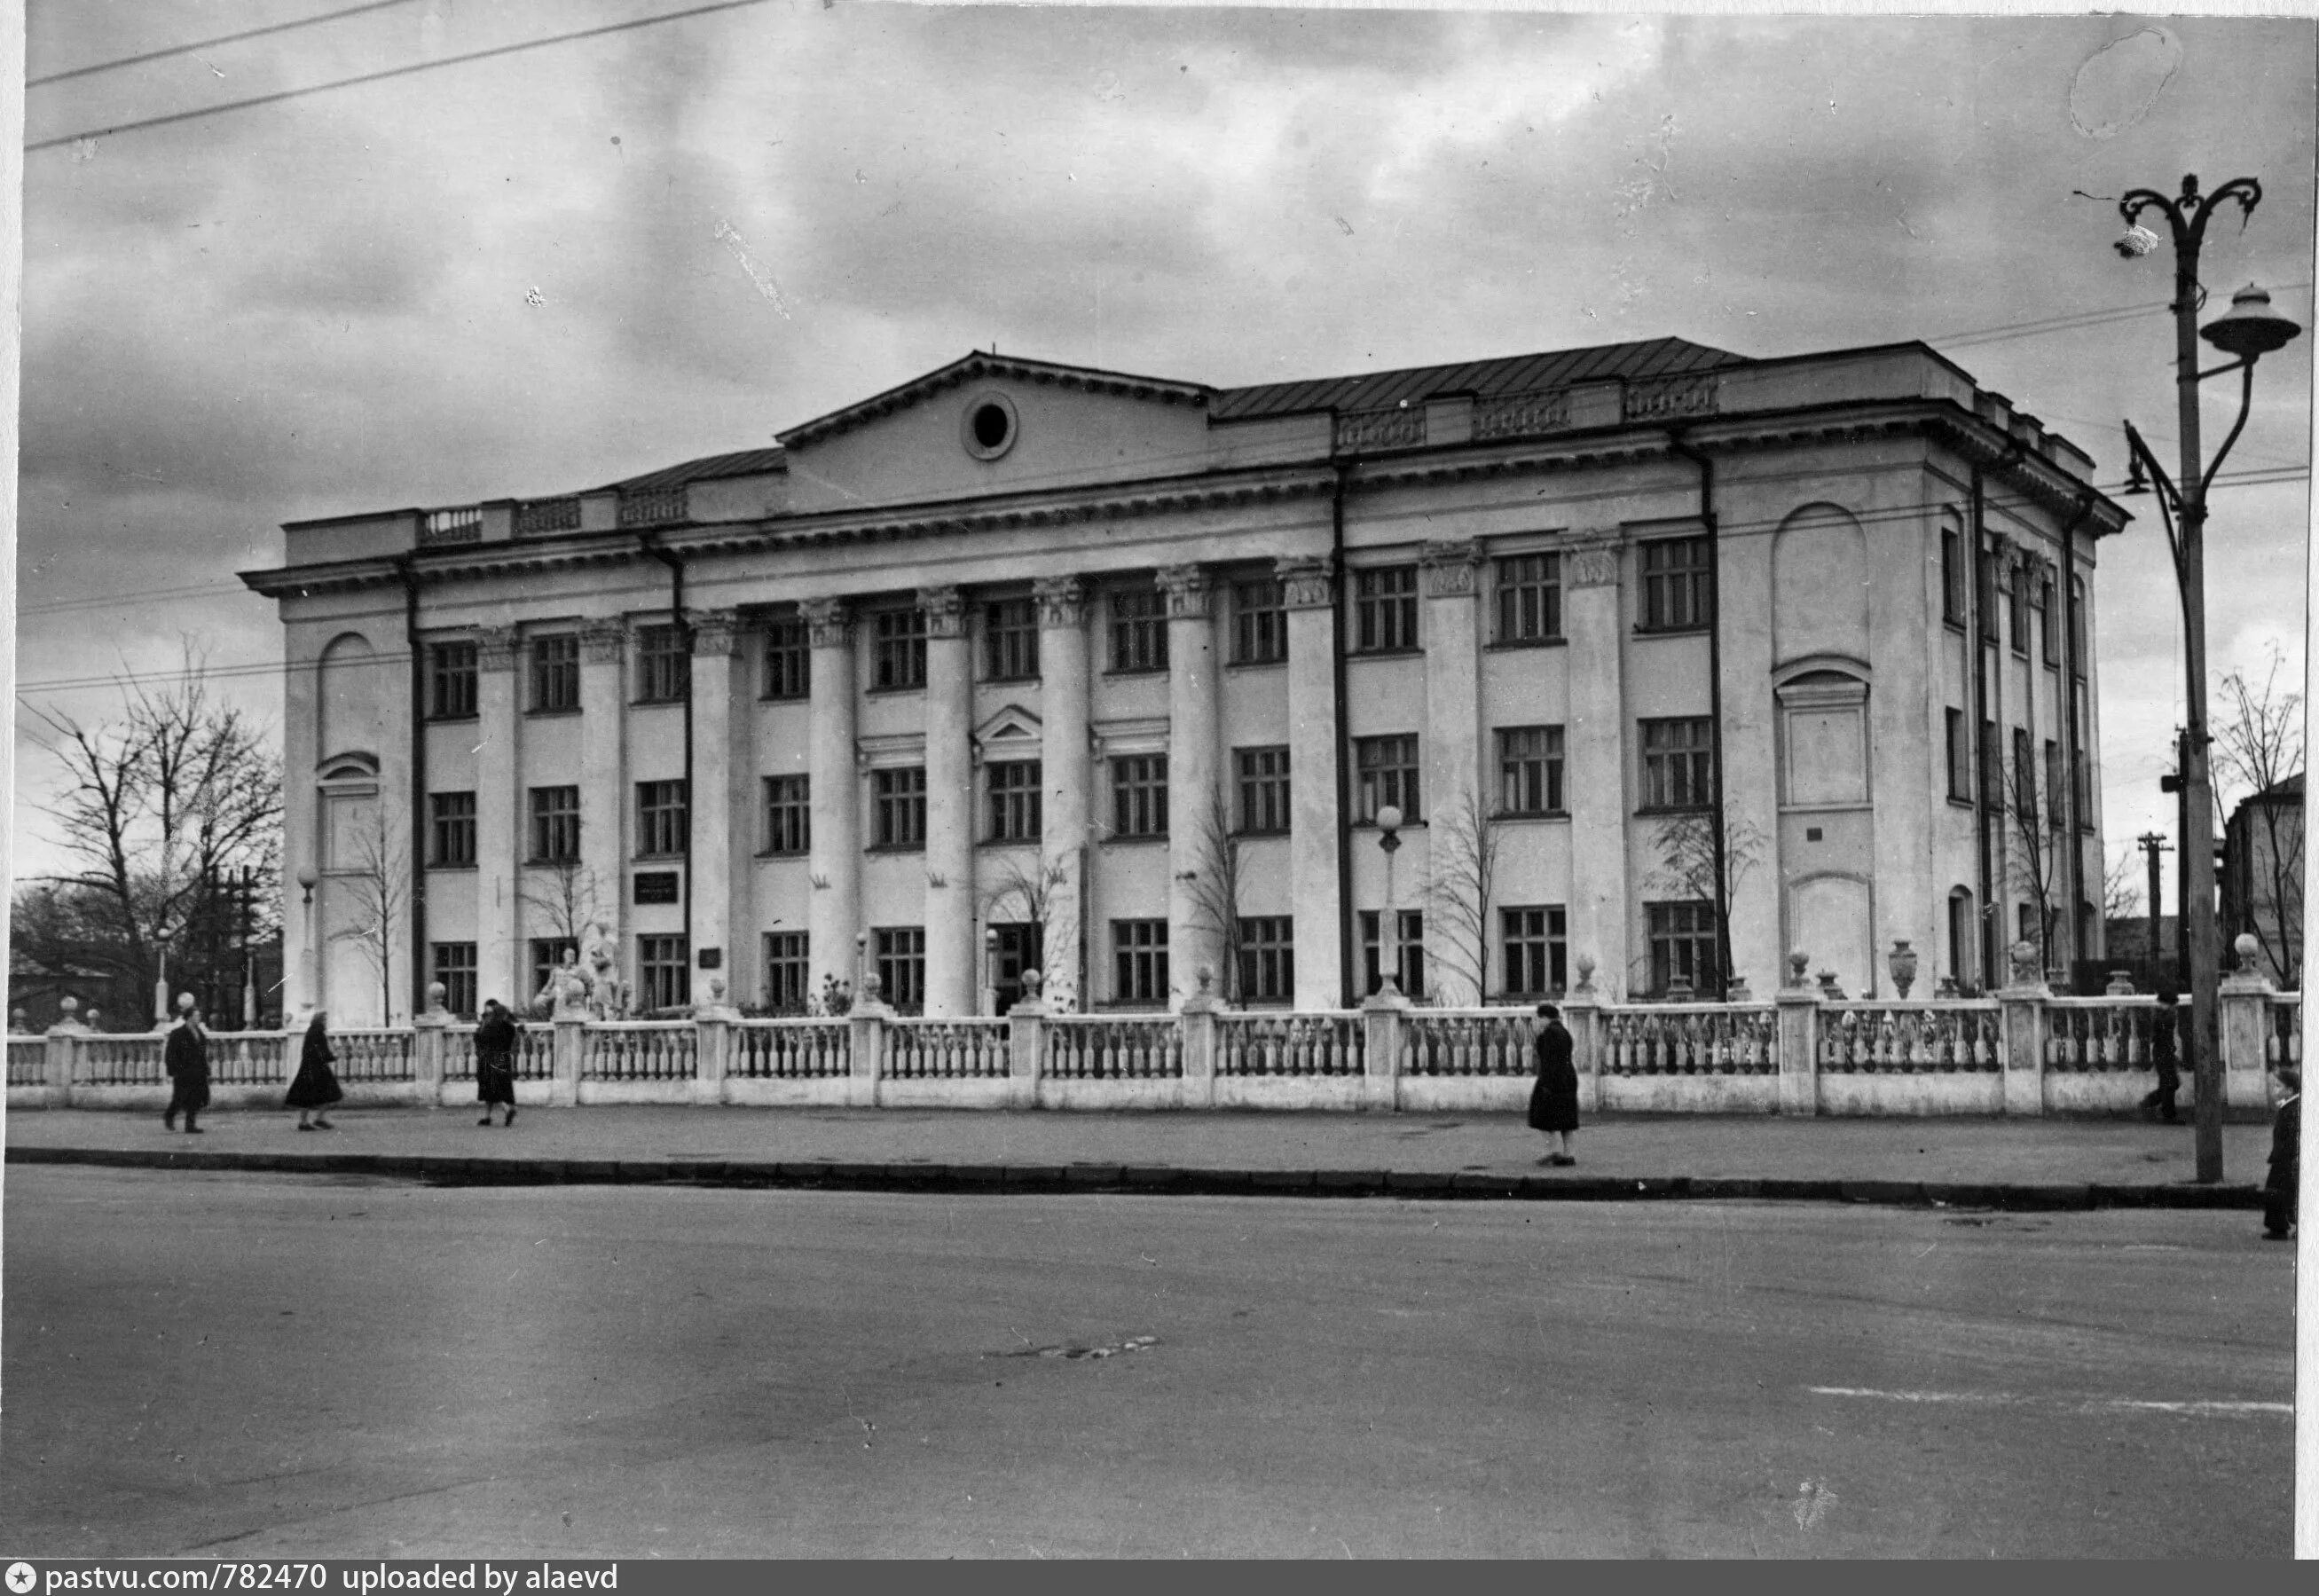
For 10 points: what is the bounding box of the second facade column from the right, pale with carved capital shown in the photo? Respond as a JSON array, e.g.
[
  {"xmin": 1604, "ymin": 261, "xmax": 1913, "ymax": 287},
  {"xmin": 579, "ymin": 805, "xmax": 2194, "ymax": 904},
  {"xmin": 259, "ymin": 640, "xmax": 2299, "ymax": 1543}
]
[{"xmin": 1394, "ymin": 543, "xmax": 1491, "ymax": 1004}]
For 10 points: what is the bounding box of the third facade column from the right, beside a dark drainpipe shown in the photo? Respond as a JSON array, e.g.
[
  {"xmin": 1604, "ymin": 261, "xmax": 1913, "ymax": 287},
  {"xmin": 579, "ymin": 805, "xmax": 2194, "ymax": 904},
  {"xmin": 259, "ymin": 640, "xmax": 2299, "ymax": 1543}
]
[{"xmin": 1277, "ymin": 554, "xmax": 1345, "ymax": 1009}]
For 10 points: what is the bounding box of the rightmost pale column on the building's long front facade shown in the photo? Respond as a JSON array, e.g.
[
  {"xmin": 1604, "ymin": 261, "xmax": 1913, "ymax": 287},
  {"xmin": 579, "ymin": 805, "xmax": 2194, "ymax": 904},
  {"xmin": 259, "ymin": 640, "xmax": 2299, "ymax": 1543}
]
[{"xmin": 1563, "ymin": 531, "xmax": 1632, "ymax": 1000}]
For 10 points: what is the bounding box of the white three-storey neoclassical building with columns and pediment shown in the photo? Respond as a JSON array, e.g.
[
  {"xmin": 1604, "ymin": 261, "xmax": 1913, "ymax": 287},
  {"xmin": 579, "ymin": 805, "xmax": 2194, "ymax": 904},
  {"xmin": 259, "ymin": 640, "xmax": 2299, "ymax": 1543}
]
[{"xmin": 246, "ymin": 339, "xmax": 2124, "ymax": 1023}]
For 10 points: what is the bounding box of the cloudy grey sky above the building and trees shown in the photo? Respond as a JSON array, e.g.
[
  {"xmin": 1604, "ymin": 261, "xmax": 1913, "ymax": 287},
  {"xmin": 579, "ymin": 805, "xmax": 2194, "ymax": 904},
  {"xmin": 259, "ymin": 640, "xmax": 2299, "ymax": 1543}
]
[{"xmin": 16, "ymin": 0, "xmax": 2315, "ymax": 900}]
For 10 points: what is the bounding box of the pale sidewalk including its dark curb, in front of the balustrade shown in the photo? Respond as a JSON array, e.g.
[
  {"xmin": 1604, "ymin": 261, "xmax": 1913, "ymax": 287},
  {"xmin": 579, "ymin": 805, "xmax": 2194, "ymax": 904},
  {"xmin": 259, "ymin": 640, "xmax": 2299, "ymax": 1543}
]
[{"xmin": 7, "ymin": 1106, "xmax": 2270, "ymax": 1208}]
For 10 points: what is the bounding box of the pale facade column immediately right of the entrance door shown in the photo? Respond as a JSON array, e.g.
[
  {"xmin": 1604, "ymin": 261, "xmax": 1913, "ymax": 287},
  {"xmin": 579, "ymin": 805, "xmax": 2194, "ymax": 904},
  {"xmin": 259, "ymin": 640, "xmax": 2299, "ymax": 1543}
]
[{"xmin": 1034, "ymin": 575, "xmax": 1090, "ymax": 1014}]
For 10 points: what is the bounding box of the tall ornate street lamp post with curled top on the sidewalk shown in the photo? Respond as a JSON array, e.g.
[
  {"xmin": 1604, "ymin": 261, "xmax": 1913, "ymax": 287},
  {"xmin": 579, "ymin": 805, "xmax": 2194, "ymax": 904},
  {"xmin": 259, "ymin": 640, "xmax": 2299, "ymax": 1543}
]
[{"xmin": 2118, "ymin": 177, "xmax": 2303, "ymax": 1183}]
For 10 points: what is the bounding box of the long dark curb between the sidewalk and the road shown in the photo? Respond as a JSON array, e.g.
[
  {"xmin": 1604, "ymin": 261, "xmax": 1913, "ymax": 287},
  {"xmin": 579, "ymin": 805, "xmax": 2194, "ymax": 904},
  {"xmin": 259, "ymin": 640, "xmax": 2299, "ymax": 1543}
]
[{"xmin": 7, "ymin": 1146, "xmax": 2263, "ymax": 1214}]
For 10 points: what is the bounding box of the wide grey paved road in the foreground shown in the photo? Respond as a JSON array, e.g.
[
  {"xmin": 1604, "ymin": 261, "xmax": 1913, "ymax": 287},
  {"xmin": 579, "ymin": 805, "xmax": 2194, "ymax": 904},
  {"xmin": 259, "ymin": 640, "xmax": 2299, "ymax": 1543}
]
[{"xmin": 0, "ymin": 1167, "xmax": 2293, "ymax": 1557}]
